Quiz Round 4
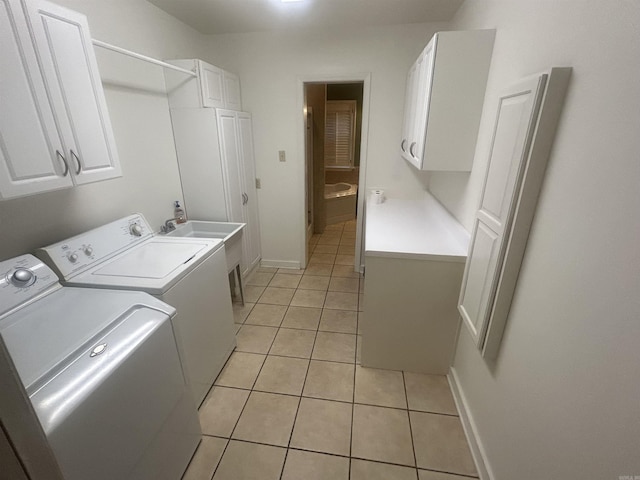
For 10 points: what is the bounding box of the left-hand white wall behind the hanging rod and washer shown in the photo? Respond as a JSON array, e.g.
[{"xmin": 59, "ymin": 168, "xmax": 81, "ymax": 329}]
[{"xmin": 0, "ymin": 0, "xmax": 206, "ymax": 260}]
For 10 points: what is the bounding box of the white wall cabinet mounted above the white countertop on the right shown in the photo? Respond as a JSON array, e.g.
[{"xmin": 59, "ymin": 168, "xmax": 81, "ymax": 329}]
[{"xmin": 400, "ymin": 30, "xmax": 495, "ymax": 172}]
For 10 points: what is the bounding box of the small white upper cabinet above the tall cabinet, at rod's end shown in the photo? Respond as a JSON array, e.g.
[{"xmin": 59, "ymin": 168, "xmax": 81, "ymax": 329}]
[{"xmin": 165, "ymin": 59, "xmax": 242, "ymax": 111}]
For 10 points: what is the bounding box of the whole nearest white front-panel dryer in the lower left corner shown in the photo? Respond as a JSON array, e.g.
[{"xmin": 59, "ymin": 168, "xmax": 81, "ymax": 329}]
[{"xmin": 0, "ymin": 255, "xmax": 201, "ymax": 480}]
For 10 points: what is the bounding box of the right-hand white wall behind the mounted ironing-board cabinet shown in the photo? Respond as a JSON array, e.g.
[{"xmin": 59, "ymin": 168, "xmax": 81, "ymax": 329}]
[{"xmin": 440, "ymin": 0, "xmax": 640, "ymax": 480}]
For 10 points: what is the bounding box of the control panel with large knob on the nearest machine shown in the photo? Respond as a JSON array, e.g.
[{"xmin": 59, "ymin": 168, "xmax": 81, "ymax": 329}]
[{"xmin": 0, "ymin": 255, "xmax": 60, "ymax": 316}]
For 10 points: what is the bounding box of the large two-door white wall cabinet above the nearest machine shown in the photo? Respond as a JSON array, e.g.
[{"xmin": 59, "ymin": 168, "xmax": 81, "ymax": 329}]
[{"xmin": 0, "ymin": 0, "xmax": 121, "ymax": 199}]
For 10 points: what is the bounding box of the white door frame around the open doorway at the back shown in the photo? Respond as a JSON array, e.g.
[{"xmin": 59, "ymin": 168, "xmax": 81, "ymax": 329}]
[{"xmin": 296, "ymin": 72, "xmax": 371, "ymax": 273}]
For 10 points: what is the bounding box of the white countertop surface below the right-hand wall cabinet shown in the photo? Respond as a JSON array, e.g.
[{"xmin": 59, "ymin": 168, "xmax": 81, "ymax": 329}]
[{"xmin": 365, "ymin": 192, "xmax": 469, "ymax": 263}]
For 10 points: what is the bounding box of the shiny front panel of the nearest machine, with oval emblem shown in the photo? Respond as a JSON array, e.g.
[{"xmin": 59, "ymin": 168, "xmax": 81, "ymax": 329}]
[{"xmin": 31, "ymin": 308, "xmax": 200, "ymax": 480}]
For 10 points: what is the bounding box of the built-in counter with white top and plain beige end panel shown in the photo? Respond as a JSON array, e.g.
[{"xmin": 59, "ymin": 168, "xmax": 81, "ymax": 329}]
[{"xmin": 362, "ymin": 192, "xmax": 469, "ymax": 374}]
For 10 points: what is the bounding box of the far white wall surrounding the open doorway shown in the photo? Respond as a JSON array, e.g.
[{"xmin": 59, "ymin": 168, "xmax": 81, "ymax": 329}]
[{"xmin": 206, "ymin": 24, "xmax": 443, "ymax": 263}]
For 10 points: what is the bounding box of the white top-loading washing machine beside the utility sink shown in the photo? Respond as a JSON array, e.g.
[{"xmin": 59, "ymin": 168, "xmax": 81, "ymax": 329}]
[{"xmin": 36, "ymin": 214, "xmax": 236, "ymax": 405}]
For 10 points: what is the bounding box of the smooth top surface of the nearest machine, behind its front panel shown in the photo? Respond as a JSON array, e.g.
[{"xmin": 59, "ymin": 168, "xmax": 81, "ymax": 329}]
[{"xmin": 0, "ymin": 288, "xmax": 175, "ymax": 395}]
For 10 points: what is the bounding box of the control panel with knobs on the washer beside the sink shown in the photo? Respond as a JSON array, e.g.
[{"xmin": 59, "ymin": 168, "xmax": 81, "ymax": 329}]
[{"xmin": 36, "ymin": 213, "xmax": 153, "ymax": 280}]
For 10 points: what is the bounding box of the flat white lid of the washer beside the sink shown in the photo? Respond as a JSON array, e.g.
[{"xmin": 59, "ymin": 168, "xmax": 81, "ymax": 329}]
[{"xmin": 93, "ymin": 240, "xmax": 208, "ymax": 279}]
